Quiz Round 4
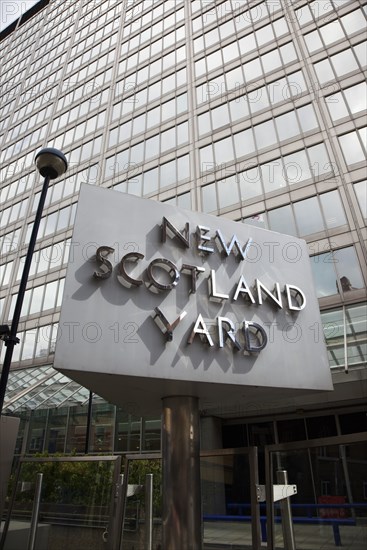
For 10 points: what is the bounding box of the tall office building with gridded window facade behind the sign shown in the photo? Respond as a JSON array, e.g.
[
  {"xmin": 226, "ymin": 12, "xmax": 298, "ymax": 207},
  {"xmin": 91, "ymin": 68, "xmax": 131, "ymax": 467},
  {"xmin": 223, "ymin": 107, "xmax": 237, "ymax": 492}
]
[{"xmin": 0, "ymin": 0, "xmax": 367, "ymax": 460}]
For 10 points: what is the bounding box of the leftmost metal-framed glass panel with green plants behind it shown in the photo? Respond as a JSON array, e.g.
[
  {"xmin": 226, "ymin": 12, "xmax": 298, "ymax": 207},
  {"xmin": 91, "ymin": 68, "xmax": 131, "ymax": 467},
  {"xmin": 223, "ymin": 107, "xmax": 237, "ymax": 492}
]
[{"xmin": 0, "ymin": 456, "xmax": 121, "ymax": 550}]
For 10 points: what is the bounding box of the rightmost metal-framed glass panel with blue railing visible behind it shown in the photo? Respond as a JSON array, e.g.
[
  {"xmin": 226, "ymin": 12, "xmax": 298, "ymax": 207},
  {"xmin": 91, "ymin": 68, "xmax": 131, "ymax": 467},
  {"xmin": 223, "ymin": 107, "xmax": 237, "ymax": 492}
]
[{"xmin": 264, "ymin": 433, "xmax": 367, "ymax": 550}]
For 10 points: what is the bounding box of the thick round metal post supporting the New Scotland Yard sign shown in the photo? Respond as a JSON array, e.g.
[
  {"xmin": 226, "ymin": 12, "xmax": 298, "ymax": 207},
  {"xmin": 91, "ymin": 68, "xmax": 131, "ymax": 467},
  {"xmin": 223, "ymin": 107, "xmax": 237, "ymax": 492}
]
[{"xmin": 162, "ymin": 396, "xmax": 202, "ymax": 550}]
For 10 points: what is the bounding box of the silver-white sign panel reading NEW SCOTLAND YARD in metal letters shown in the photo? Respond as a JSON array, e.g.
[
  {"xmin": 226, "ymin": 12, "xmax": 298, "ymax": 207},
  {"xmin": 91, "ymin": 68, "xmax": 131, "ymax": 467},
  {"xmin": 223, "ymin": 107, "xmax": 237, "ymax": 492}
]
[{"xmin": 55, "ymin": 185, "xmax": 332, "ymax": 411}]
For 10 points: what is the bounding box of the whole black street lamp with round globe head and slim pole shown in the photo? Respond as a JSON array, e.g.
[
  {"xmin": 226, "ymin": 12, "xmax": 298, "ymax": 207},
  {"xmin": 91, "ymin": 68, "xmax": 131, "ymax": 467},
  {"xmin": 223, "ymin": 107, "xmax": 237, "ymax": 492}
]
[{"xmin": 0, "ymin": 147, "xmax": 68, "ymax": 415}]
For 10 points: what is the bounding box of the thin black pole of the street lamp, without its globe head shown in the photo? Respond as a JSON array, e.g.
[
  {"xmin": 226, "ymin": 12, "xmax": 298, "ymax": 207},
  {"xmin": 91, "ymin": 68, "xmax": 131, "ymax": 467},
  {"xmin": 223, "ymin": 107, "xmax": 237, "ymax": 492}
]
[{"xmin": 0, "ymin": 176, "xmax": 51, "ymax": 414}]
